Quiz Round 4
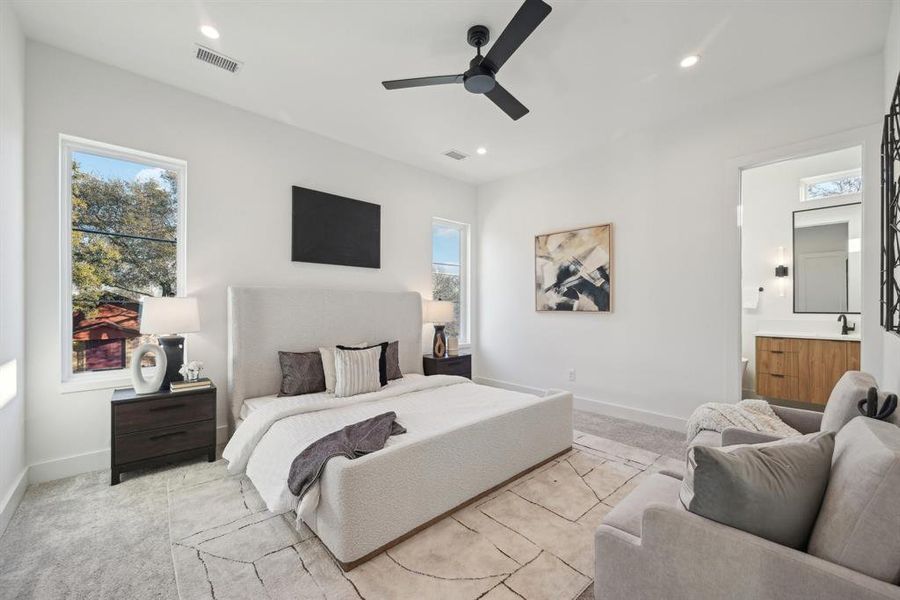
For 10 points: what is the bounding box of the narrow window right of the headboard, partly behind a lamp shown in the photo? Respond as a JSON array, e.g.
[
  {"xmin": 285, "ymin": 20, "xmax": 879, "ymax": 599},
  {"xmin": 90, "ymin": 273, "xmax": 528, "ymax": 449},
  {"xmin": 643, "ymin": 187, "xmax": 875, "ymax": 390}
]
[{"xmin": 431, "ymin": 219, "xmax": 469, "ymax": 344}]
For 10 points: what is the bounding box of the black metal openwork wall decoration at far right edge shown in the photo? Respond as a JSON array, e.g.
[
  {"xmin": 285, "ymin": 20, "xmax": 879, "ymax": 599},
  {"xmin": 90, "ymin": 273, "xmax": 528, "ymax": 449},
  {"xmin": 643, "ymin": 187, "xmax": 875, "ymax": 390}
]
[{"xmin": 881, "ymin": 75, "xmax": 900, "ymax": 335}]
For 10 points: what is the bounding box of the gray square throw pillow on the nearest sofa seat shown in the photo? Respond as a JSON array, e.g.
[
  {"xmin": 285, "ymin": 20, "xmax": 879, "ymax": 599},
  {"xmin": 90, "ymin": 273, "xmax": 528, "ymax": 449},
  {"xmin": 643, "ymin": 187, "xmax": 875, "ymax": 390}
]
[{"xmin": 680, "ymin": 431, "xmax": 834, "ymax": 550}]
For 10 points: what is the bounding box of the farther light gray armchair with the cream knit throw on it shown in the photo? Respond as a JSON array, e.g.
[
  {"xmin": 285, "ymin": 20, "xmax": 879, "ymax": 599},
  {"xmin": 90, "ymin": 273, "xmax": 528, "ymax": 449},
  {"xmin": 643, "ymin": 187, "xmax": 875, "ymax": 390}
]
[{"xmin": 690, "ymin": 371, "xmax": 884, "ymax": 447}]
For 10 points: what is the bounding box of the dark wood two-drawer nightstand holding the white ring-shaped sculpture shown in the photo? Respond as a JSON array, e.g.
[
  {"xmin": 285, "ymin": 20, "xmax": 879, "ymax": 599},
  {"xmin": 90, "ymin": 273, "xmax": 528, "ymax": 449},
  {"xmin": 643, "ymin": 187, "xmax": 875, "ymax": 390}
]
[{"xmin": 109, "ymin": 386, "xmax": 216, "ymax": 485}]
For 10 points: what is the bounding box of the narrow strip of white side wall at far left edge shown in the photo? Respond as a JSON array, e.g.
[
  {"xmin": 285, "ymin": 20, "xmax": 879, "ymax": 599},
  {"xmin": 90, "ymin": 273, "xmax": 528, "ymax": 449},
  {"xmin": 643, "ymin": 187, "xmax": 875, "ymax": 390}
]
[{"xmin": 0, "ymin": 2, "xmax": 27, "ymax": 533}]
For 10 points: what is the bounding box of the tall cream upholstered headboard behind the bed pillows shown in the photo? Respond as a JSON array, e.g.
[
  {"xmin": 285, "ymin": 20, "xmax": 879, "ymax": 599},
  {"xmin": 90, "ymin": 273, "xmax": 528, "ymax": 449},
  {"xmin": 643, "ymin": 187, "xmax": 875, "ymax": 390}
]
[{"xmin": 228, "ymin": 286, "xmax": 422, "ymax": 419}]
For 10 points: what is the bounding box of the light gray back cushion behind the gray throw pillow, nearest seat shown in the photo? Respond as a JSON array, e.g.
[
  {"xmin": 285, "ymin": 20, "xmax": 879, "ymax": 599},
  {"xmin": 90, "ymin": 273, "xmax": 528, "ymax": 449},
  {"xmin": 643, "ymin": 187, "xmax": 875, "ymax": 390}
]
[{"xmin": 809, "ymin": 417, "xmax": 900, "ymax": 584}]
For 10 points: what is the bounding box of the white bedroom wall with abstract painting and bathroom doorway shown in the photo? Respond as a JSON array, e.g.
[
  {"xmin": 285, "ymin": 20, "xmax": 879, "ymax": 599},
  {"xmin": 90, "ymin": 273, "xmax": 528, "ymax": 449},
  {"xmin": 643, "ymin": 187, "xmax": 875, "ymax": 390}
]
[{"xmin": 476, "ymin": 55, "xmax": 883, "ymax": 428}]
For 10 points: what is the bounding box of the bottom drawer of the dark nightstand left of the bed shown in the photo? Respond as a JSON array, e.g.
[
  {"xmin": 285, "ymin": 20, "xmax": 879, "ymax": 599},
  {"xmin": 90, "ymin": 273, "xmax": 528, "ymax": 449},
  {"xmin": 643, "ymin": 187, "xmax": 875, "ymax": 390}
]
[{"xmin": 115, "ymin": 419, "xmax": 216, "ymax": 465}]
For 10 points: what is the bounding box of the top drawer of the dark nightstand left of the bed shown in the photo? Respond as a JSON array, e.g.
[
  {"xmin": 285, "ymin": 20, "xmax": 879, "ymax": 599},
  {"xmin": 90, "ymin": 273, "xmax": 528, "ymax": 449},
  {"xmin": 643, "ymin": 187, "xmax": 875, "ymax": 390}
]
[{"xmin": 113, "ymin": 393, "xmax": 216, "ymax": 434}]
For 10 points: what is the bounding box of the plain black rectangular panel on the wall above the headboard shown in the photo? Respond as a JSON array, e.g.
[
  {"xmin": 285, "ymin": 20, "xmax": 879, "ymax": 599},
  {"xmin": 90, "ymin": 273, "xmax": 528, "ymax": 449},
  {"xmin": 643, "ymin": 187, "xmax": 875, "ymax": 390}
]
[{"xmin": 291, "ymin": 186, "xmax": 381, "ymax": 269}]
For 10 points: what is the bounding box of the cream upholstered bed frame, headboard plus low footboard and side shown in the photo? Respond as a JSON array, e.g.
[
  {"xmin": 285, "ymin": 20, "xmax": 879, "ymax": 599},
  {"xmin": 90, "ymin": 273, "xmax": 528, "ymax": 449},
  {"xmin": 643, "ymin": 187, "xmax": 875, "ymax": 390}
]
[{"xmin": 228, "ymin": 287, "xmax": 572, "ymax": 570}]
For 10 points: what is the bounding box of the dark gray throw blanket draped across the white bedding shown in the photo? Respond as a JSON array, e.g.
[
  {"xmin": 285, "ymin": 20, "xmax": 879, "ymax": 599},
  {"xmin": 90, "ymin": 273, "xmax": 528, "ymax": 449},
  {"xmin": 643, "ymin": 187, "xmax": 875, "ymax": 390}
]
[{"xmin": 288, "ymin": 411, "xmax": 406, "ymax": 498}]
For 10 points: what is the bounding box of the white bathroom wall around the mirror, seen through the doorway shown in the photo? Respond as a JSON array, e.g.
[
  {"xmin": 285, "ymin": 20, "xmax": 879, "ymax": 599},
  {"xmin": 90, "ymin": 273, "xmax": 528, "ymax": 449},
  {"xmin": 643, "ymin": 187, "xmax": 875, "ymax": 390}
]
[{"xmin": 741, "ymin": 147, "xmax": 860, "ymax": 390}]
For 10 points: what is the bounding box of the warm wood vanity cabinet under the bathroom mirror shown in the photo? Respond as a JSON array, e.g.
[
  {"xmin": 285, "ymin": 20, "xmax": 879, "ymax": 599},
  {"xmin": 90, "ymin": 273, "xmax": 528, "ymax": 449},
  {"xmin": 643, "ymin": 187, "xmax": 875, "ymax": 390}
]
[{"xmin": 756, "ymin": 336, "xmax": 859, "ymax": 405}]
